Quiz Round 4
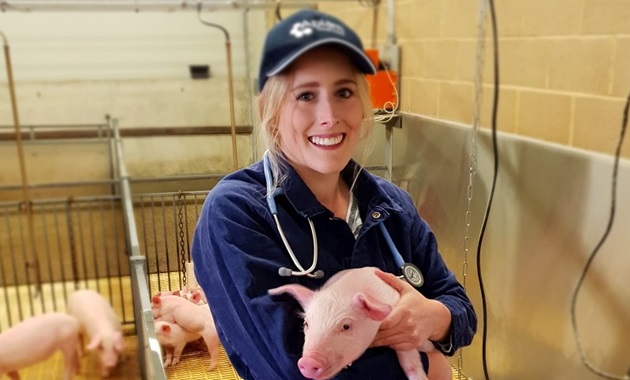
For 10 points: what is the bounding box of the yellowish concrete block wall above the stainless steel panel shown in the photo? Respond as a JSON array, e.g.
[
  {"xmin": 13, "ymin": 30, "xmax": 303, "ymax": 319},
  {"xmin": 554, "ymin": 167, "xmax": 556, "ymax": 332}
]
[{"xmin": 320, "ymin": 0, "xmax": 630, "ymax": 158}]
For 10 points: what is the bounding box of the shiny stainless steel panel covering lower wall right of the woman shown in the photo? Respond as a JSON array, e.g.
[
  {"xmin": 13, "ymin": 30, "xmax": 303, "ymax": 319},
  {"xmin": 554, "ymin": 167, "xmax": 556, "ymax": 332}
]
[{"xmin": 392, "ymin": 115, "xmax": 630, "ymax": 380}]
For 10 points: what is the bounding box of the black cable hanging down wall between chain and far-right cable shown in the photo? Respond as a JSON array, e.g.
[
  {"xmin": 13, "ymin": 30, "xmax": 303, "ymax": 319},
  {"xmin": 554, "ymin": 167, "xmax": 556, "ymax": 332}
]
[{"xmin": 477, "ymin": 0, "xmax": 499, "ymax": 380}]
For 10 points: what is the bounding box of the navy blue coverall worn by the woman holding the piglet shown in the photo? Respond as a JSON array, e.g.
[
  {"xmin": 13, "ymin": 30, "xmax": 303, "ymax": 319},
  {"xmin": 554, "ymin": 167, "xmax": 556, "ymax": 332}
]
[{"xmin": 192, "ymin": 161, "xmax": 477, "ymax": 380}]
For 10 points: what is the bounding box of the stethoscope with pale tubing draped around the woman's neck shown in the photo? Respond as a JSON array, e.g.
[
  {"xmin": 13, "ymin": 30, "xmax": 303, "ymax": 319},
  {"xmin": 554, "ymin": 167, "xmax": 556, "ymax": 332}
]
[{"xmin": 263, "ymin": 151, "xmax": 424, "ymax": 288}]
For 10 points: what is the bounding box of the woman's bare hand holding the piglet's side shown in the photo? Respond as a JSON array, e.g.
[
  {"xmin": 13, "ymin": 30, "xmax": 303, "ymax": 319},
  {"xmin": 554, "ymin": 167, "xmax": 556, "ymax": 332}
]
[{"xmin": 372, "ymin": 270, "xmax": 451, "ymax": 351}]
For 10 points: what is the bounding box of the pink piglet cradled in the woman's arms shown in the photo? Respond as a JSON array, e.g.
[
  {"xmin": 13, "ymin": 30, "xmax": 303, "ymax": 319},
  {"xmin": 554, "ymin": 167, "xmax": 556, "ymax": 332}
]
[{"xmin": 268, "ymin": 267, "xmax": 435, "ymax": 380}]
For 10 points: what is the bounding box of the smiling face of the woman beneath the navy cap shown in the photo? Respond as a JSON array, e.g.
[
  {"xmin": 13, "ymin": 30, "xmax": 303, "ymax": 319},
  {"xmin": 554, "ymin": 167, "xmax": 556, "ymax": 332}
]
[{"xmin": 278, "ymin": 47, "xmax": 363, "ymax": 177}]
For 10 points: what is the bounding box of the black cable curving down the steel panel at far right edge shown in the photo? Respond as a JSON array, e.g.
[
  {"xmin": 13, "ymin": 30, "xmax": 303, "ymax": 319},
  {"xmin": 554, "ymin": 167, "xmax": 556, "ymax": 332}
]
[{"xmin": 571, "ymin": 87, "xmax": 630, "ymax": 379}]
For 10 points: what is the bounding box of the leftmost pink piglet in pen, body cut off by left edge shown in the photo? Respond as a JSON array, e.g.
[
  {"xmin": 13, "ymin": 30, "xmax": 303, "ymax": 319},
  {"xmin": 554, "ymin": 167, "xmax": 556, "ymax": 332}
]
[{"xmin": 0, "ymin": 313, "xmax": 80, "ymax": 380}]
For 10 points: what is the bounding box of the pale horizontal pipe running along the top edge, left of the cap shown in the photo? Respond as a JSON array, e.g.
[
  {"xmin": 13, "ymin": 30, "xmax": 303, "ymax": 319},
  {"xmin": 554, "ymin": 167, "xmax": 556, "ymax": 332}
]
[{"xmin": 0, "ymin": 0, "xmax": 357, "ymax": 12}]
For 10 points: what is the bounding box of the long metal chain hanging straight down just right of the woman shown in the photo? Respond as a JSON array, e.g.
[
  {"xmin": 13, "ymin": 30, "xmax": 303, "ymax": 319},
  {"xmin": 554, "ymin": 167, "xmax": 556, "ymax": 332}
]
[{"xmin": 457, "ymin": 0, "xmax": 494, "ymax": 380}]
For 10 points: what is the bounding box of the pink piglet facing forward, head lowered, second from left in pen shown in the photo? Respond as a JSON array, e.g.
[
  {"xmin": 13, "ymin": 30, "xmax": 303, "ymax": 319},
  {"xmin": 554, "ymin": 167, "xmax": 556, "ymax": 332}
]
[{"xmin": 67, "ymin": 290, "xmax": 125, "ymax": 377}]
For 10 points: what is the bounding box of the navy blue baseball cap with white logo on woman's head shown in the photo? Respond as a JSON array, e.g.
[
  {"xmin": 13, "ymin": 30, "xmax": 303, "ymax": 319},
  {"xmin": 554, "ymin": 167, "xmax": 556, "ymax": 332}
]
[{"xmin": 258, "ymin": 9, "xmax": 376, "ymax": 91}]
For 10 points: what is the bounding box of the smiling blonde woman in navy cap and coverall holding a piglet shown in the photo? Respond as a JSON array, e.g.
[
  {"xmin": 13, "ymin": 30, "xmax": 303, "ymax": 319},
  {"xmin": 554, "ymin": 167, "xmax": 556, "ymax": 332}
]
[{"xmin": 192, "ymin": 10, "xmax": 477, "ymax": 380}]
